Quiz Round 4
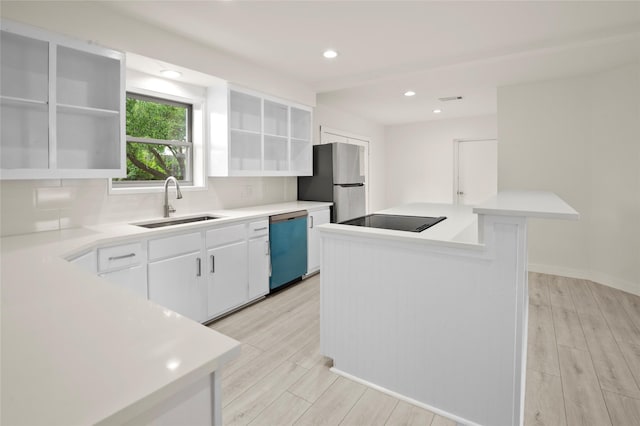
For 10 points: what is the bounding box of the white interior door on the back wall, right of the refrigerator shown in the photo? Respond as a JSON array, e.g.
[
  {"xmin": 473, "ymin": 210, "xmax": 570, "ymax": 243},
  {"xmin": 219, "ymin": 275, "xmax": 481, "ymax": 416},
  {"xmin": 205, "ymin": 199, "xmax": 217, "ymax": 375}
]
[{"xmin": 454, "ymin": 139, "xmax": 498, "ymax": 205}]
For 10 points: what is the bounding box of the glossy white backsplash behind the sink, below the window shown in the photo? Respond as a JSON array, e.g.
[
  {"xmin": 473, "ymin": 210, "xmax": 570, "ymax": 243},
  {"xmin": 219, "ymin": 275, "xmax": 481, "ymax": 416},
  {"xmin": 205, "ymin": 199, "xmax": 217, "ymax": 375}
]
[{"xmin": 0, "ymin": 177, "xmax": 297, "ymax": 236}]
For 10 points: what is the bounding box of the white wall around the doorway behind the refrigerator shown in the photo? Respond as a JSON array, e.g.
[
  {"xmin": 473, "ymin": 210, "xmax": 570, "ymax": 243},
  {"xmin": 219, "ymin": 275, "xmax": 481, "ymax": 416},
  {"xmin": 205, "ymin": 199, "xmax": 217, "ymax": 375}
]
[{"xmin": 313, "ymin": 101, "xmax": 389, "ymax": 211}]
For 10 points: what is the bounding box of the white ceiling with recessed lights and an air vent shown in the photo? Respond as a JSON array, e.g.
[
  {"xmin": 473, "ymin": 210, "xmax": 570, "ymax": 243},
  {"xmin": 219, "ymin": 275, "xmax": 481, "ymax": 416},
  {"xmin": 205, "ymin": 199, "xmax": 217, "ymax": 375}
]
[{"xmin": 108, "ymin": 1, "xmax": 640, "ymax": 124}]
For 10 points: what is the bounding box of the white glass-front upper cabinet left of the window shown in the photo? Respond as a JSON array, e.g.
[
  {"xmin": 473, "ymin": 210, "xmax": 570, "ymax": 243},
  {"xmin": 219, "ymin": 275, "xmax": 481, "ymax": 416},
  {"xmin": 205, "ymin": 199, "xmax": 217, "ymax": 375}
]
[{"xmin": 0, "ymin": 21, "xmax": 126, "ymax": 179}]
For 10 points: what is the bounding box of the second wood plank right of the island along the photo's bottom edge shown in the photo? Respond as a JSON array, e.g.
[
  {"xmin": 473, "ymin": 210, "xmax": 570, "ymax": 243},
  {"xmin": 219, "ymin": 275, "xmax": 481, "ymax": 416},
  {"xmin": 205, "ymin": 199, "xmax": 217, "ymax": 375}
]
[{"xmin": 558, "ymin": 346, "xmax": 611, "ymax": 426}]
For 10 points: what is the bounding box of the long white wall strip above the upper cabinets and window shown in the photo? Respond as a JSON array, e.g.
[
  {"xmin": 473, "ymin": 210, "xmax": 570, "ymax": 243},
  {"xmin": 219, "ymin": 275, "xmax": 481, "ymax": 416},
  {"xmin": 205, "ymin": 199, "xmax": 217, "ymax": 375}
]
[{"xmin": 0, "ymin": 1, "xmax": 315, "ymax": 106}]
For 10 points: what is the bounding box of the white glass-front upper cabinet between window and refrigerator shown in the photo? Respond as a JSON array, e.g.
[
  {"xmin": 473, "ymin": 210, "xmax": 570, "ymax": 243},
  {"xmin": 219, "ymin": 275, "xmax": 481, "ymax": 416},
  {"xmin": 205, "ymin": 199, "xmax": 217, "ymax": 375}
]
[{"xmin": 208, "ymin": 85, "xmax": 313, "ymax": 176}]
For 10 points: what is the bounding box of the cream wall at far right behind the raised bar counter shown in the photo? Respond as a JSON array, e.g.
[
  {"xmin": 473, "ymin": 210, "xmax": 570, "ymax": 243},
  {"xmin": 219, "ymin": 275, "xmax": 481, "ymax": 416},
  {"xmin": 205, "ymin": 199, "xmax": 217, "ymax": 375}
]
[{"xmin": 498, "ymin": 64, "xmax": 640, "ymax": 294}]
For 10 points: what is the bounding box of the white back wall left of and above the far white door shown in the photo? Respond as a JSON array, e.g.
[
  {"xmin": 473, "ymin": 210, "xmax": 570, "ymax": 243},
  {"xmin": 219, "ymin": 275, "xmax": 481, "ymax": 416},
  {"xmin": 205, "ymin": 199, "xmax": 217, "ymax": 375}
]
[{"xmin": 384, "ymin": 115, "xmax": 500, "ymax": 206}]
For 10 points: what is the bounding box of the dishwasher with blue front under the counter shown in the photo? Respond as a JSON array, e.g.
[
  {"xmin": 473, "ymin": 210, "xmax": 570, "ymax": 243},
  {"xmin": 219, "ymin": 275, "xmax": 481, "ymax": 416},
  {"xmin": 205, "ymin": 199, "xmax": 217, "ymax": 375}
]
[{"xmin": 269, "ymin": 210, "xmax": 307, "ymax": 291}]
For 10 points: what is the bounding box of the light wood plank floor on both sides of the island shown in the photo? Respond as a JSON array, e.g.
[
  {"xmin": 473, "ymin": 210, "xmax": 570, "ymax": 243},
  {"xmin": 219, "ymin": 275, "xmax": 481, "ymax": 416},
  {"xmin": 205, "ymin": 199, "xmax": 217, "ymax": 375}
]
[{"xmin": 211, "ymin": 273, "xmax": 640, "ymax": 426}]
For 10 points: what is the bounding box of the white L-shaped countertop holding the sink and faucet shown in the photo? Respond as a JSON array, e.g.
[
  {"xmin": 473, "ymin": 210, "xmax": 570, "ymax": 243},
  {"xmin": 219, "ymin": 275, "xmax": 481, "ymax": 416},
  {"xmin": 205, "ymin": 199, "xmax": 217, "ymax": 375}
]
[{"xmin": 0, "ymin": 202, "xmax": 330, "ymax": 425}]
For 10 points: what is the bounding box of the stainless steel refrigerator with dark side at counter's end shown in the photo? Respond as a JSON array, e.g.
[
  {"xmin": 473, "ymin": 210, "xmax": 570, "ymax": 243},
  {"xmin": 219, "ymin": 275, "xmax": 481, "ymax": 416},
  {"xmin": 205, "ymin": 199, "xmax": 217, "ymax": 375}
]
[{"xmin": 298, "ymin": 142, "xmax": 366, "ymax": 222}]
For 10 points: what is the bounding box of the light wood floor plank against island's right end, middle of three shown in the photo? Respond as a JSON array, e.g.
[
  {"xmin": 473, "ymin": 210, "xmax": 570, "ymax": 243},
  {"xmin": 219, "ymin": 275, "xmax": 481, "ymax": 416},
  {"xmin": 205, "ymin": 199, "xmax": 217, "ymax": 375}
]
[{"xmin": 527, "ymin": 305, "xmax": 560, "ymax": 376}]
